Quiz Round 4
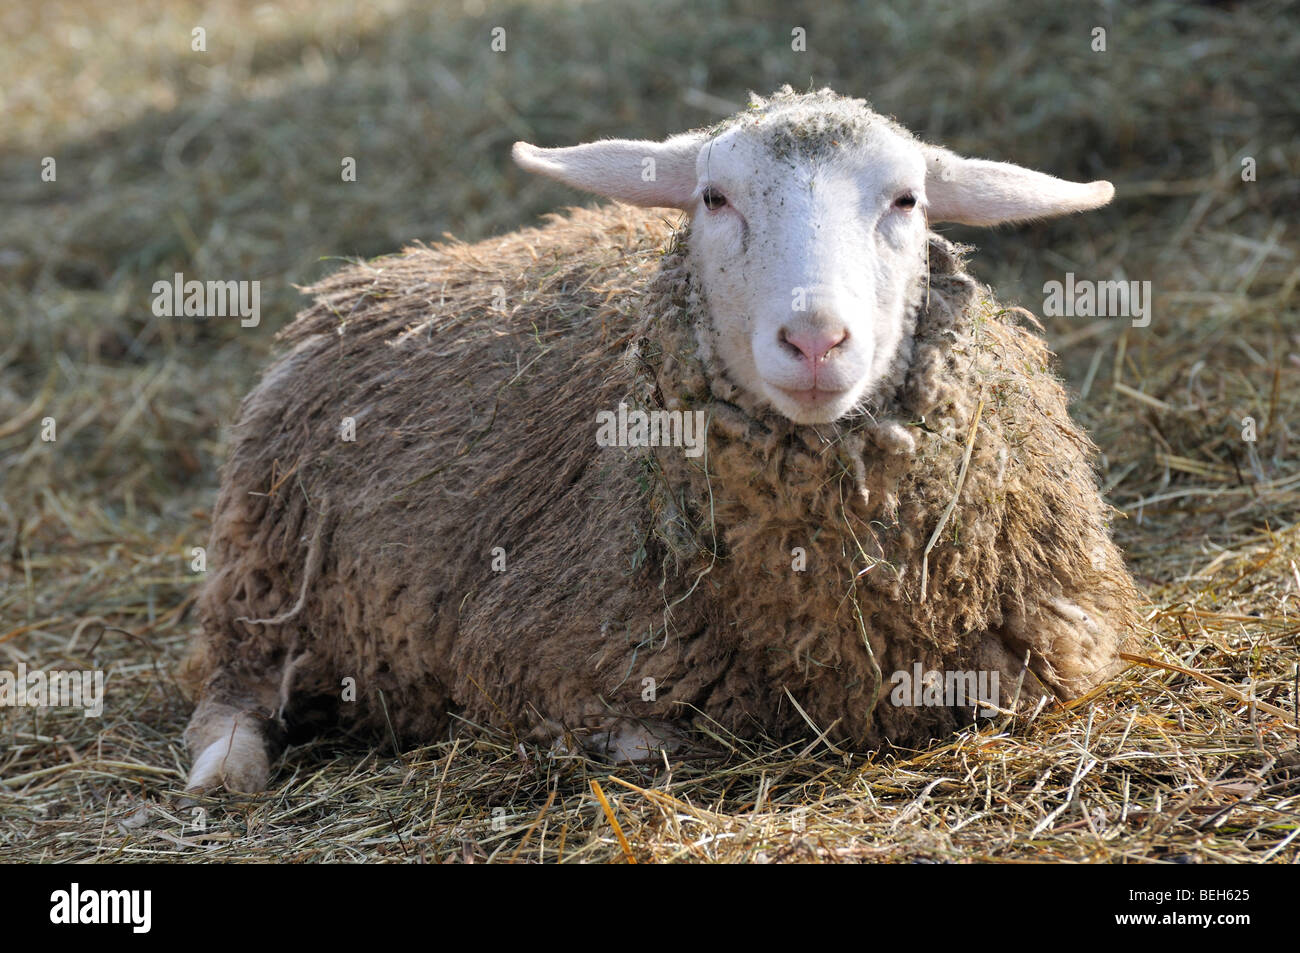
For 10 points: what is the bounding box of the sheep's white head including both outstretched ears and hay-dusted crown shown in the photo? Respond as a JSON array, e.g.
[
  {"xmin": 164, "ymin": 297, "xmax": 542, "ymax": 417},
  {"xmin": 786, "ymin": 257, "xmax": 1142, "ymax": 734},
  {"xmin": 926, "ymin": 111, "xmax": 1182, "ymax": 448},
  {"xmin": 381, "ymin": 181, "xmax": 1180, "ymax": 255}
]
[{"xmin": 514, "ymin": 87, "xmax": 1114, "ymax": 424}]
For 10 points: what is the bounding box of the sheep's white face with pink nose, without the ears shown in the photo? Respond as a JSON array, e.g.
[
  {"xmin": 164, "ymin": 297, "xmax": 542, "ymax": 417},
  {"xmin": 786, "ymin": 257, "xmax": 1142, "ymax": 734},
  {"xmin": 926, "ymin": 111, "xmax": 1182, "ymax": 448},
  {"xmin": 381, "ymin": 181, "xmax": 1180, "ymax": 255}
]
[{"xmin": 688, "ymin": 124, "xmax": 926, "ymax": 424}]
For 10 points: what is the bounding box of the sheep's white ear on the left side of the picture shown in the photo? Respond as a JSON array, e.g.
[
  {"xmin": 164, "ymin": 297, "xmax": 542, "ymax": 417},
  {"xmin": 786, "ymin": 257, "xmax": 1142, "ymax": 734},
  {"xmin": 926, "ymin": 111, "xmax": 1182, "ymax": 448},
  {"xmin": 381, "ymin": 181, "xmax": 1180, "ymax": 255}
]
[{"xmin": 511, "ymin": 134, "xmax": 705, "ymax": 209}]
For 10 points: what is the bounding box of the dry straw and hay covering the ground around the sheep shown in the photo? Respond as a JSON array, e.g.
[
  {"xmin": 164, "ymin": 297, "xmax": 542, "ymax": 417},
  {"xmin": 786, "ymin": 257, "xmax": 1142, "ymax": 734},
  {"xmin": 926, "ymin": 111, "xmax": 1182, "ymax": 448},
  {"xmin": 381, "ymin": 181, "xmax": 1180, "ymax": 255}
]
[{"xmin": 0, "ymin": 0, "xmax": 1300, "ymax": 862}]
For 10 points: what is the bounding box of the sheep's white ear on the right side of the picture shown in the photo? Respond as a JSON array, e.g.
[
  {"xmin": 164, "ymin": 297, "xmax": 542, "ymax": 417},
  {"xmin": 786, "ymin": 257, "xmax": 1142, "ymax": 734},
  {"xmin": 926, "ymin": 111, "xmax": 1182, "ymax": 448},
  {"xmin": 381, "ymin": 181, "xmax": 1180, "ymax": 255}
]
[{"xmin": 926, "ymin": 146, "xmax": 1115, "ymax": 225}]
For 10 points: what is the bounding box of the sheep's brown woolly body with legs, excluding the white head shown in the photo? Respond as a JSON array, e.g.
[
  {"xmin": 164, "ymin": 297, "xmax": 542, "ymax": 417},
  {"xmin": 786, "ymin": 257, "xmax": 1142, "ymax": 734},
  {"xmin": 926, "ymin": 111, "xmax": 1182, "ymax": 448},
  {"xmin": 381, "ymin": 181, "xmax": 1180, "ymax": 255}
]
[{"xmin": 187, "ymin": 205, "xmax": 1136, "ymax": 788}]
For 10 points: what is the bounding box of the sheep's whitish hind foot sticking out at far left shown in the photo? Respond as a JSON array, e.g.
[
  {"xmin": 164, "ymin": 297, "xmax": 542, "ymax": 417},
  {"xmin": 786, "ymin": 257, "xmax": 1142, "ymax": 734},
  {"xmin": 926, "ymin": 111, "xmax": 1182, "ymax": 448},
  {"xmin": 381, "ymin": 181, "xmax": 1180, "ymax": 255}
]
[{"xmin": 185, "ymin": 685, "xmax": 283, "ymax": 793}]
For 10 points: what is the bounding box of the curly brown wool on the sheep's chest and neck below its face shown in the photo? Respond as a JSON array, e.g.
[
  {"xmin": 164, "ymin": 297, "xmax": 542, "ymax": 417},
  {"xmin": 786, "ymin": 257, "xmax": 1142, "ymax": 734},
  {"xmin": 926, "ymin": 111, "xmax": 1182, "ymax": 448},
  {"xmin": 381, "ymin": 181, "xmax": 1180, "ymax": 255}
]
[{"xmin": 629, "ymin": 226, "xmax": 1138, "ymax": 744}]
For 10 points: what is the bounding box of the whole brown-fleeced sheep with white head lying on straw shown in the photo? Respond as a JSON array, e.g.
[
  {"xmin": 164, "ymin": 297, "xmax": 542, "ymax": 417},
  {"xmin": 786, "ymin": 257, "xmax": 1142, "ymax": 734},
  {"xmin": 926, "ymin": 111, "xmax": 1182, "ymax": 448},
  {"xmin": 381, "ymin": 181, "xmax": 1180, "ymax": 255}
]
[{"xmin": 183, "ymin": 87, "xmax": 1139, "ymax": 792}]
